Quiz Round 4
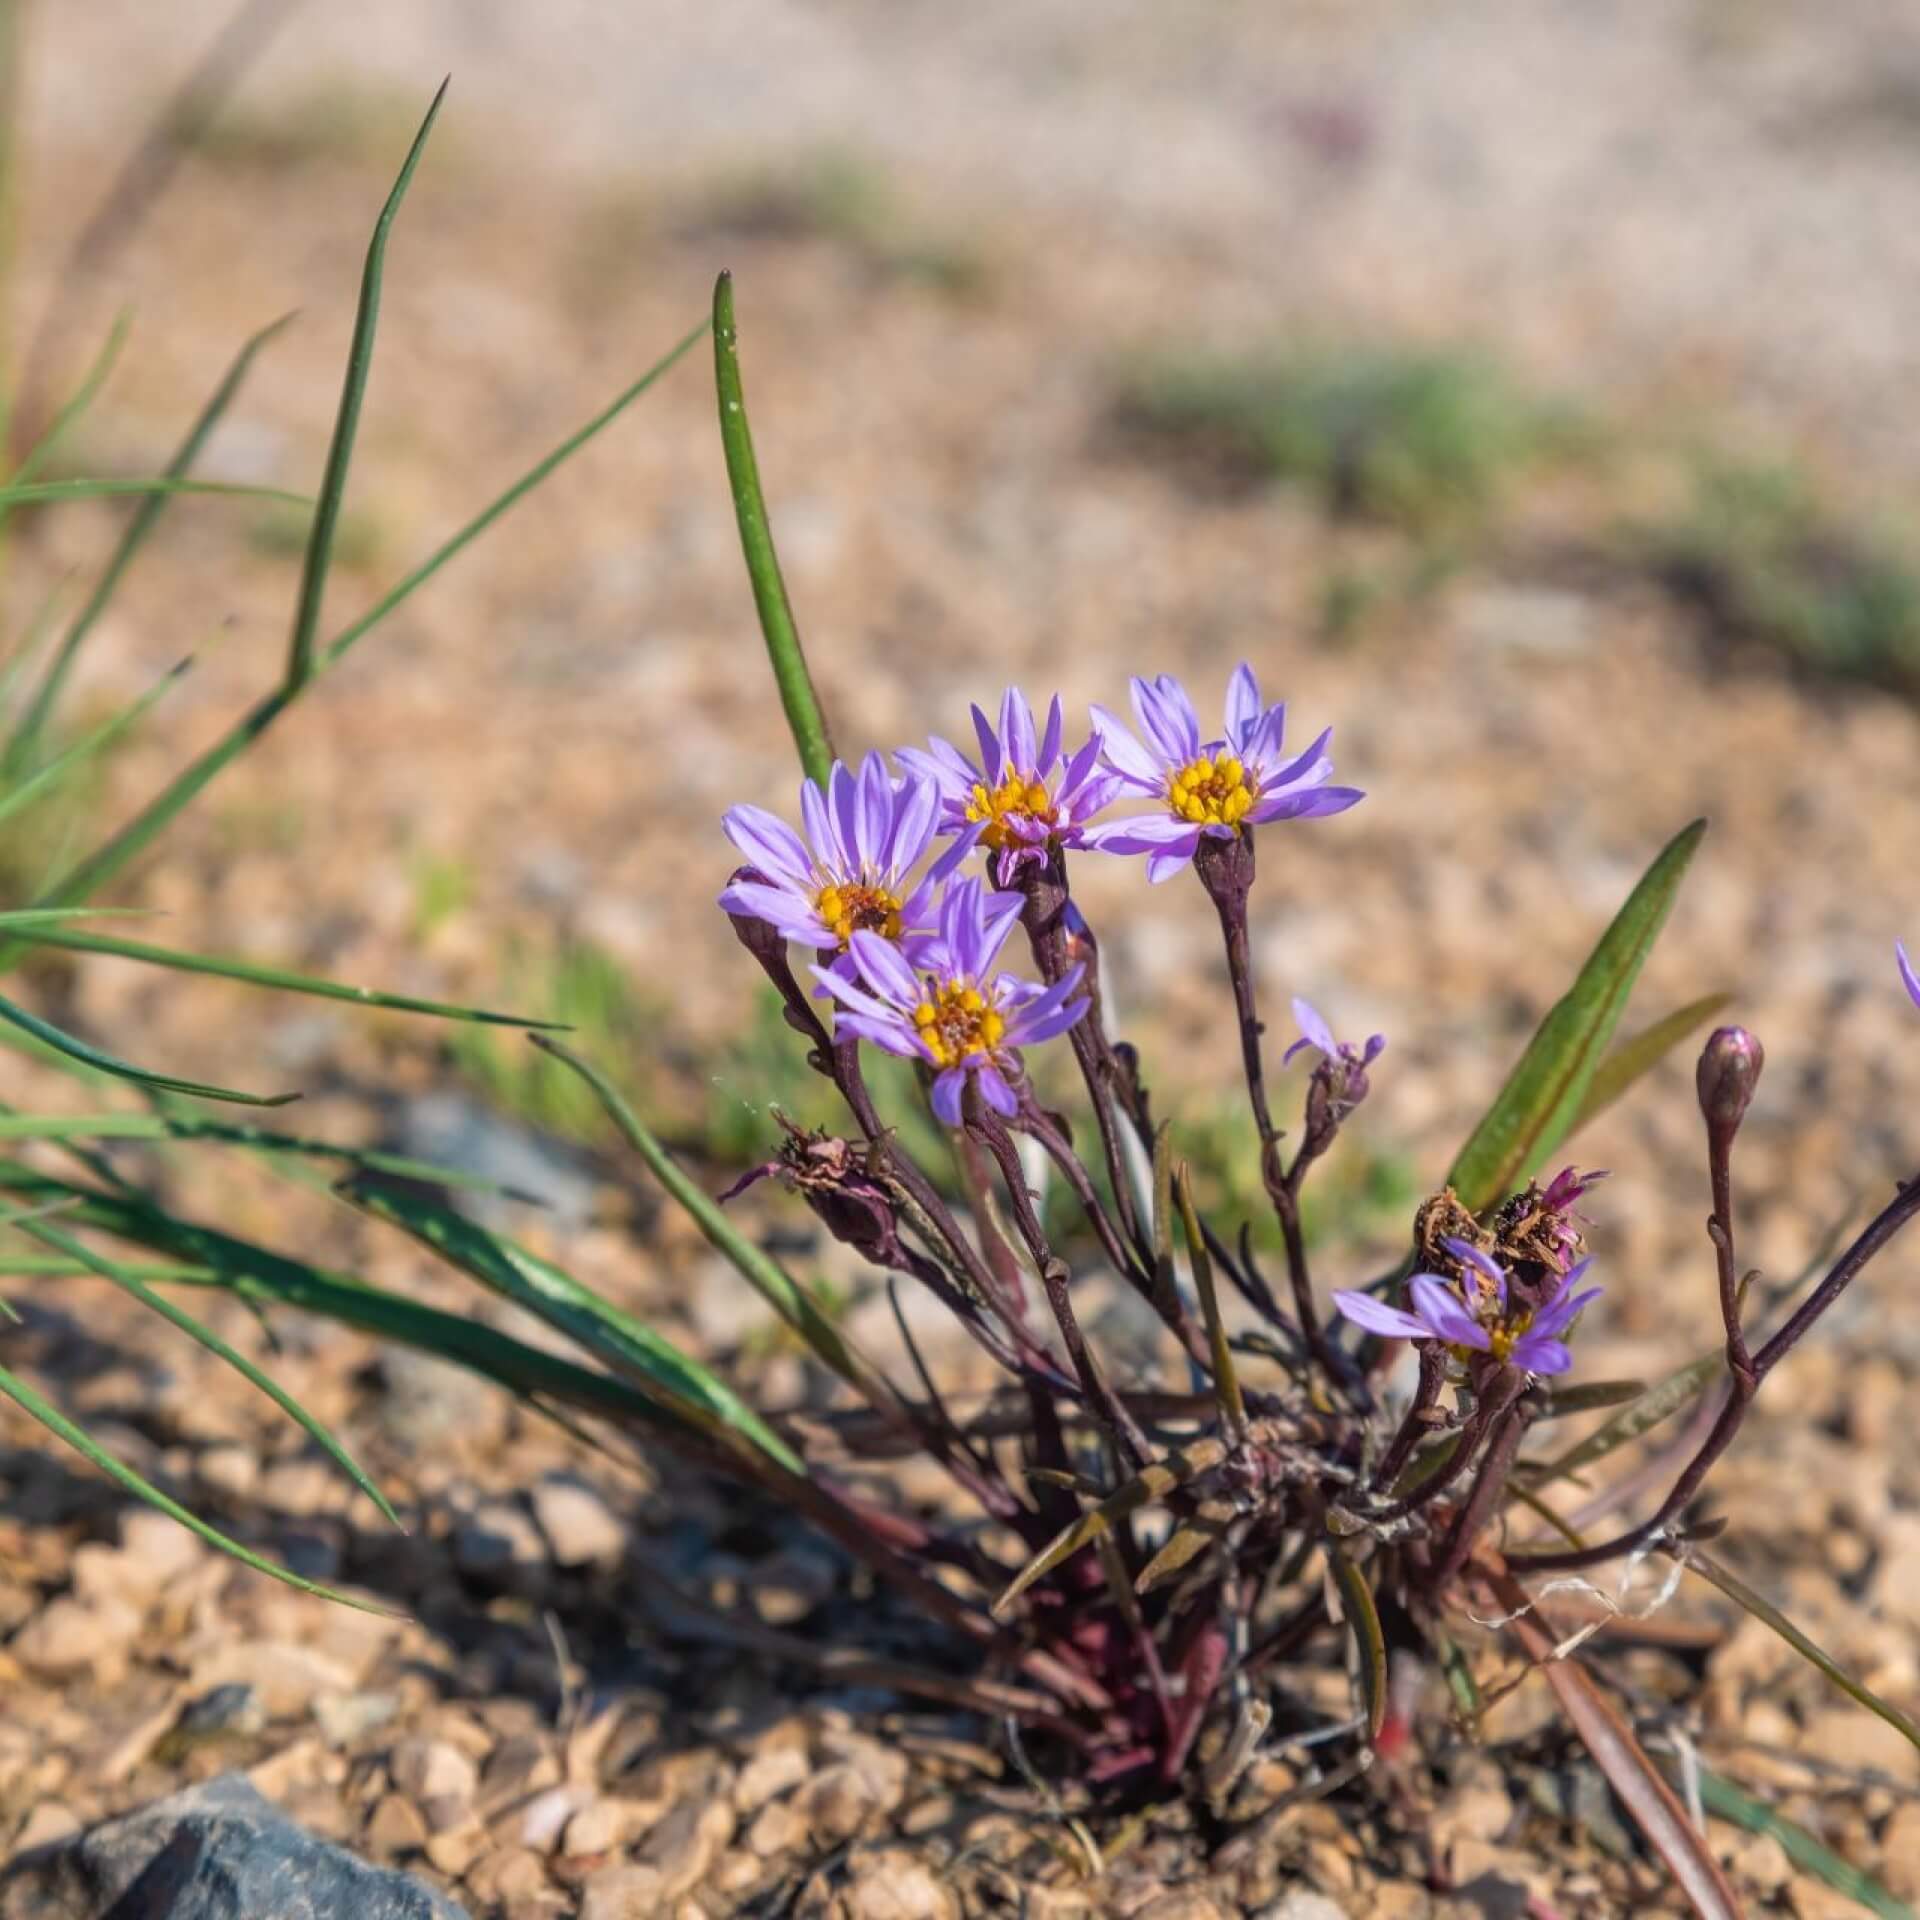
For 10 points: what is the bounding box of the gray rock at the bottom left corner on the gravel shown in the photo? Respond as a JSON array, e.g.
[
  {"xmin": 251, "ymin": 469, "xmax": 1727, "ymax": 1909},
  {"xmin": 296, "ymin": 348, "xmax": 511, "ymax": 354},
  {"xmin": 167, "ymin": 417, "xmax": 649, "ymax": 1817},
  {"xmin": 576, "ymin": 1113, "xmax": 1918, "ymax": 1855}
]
[{"xmin": 0, "ymin": 1774, "xmax": 467, "ymax": 1920}]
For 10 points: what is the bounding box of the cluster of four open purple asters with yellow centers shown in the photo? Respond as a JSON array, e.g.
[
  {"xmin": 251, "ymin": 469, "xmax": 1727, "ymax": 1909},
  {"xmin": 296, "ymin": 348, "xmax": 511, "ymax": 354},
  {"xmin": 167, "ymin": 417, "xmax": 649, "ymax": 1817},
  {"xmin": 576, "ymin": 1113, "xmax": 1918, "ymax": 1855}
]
[{"xmin": 720, "ymin": 664, "xmax": 1382, "ymax": 1125}]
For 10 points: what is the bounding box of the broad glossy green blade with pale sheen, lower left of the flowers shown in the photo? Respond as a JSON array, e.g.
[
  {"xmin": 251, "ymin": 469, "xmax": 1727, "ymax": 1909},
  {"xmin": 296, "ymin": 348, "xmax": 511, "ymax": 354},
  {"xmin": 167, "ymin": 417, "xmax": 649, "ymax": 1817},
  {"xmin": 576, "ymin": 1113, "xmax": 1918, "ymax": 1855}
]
[{"xmin": 340, "ymin": 1181, "xmax": 806, "ymax": 1476}]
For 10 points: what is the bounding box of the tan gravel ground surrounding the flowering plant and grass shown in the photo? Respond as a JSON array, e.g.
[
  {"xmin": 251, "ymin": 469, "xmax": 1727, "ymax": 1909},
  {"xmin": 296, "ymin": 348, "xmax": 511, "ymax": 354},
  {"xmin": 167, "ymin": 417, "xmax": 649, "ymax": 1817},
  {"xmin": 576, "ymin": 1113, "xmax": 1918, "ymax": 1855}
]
[{"xmin": 0, "ymin": 0, "xmax": 1920, "ymax": 1920}]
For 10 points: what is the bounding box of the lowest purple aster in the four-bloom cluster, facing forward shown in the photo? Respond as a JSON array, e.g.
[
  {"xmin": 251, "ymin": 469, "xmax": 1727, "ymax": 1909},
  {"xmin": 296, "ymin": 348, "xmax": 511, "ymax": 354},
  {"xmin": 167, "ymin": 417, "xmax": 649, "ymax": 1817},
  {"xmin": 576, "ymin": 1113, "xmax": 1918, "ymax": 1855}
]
[{"xmin": 814, "ymin": 879, "xmax": 1087, "ymax": 1127}]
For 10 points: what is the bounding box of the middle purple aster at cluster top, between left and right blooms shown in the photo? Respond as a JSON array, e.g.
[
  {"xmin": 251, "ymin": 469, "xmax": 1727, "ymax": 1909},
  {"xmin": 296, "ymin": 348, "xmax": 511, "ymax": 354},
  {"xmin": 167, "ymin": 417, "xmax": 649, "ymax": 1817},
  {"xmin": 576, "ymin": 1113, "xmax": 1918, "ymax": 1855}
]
[{"xmin": 899, "ymin": 687, "xmax": 1119, "ymax": 887}]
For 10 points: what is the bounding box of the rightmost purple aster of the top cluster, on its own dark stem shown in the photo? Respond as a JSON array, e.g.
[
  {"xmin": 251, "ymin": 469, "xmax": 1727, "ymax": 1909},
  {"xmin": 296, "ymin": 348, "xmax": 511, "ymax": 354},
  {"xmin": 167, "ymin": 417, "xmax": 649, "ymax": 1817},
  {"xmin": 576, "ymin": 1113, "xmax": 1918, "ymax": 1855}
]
[{"xmin": 1081, "ymin": 660, "xmax": 1361, "ymax": 881}]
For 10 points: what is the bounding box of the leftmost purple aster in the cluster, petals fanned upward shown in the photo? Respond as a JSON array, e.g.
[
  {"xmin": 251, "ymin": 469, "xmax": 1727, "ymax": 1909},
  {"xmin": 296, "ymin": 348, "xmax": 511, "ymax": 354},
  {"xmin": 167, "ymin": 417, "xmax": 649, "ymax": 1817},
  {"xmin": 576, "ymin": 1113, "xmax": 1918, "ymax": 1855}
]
[{"xmin": 720, "ymin": 753, "xmax": 972, "ymax": 954}]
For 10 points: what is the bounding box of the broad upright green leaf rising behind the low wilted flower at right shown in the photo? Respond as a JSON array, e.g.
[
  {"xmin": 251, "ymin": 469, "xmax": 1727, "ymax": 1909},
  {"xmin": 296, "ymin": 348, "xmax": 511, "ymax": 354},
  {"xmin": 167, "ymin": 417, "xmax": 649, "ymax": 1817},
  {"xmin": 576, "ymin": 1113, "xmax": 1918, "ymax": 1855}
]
[{"xmin": 1448, "ymin": 820, "xmax": 1707, "ymax": 1213}]
